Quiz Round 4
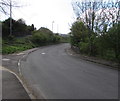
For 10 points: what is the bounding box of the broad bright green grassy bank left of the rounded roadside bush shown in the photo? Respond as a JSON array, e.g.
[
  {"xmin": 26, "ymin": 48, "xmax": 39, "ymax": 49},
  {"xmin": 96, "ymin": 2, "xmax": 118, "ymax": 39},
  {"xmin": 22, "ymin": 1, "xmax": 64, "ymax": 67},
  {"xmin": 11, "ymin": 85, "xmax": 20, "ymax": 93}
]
[{"xmin": 2, "ymin": 37, "xmax": 36, "ymax": 54}]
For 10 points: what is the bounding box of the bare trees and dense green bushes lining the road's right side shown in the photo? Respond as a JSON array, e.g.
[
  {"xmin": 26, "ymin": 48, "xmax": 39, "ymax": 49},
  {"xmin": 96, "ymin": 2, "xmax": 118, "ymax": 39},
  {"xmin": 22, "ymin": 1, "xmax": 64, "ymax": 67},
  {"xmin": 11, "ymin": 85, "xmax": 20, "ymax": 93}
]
[{"xmin": 70, "ymin": 1, "xmax": 120, "ymax": 62}]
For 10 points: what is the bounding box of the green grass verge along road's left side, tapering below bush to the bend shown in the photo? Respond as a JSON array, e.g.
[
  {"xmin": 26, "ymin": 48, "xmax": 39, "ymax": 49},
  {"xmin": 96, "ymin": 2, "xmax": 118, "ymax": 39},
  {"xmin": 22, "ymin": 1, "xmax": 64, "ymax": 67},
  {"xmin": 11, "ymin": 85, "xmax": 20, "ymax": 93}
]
[{"xmin": 2, "ymin": 36, "xmax": 68, "ymax": 54}]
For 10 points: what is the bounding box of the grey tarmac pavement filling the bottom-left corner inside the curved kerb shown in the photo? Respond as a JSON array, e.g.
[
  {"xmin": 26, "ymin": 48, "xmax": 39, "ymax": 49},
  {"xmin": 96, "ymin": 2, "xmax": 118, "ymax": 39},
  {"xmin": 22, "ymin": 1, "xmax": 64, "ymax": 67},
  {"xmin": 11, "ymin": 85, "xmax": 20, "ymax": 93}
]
[{"xmin": 2, "ymin": 66, "xmax": 31, "ymax": 101}]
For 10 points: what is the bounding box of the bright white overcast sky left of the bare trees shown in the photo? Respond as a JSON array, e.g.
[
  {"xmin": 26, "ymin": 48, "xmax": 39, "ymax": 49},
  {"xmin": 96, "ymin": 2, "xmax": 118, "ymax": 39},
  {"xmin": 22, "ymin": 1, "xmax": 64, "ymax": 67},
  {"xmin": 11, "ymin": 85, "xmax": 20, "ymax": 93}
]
[{"xmin": 2, "ymin": 0, "xmax": 75, "ymax": 34}]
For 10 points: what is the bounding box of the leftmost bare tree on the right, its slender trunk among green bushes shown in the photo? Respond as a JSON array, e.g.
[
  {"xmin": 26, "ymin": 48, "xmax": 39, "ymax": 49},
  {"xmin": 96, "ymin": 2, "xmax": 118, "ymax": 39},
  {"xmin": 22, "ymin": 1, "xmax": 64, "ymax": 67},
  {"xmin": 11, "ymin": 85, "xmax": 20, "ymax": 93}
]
[{"xmin": 72, "ymin": 0, "xmax": 101, "ymax": 55}]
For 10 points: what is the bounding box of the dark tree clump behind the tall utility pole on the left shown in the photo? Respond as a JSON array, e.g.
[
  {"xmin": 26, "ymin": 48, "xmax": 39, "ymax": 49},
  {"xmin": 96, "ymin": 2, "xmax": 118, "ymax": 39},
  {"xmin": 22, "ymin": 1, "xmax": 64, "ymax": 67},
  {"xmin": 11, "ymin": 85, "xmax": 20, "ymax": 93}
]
[{"xmin": 2, "ymin": 18, "xmax": 36, "ymax": 38}]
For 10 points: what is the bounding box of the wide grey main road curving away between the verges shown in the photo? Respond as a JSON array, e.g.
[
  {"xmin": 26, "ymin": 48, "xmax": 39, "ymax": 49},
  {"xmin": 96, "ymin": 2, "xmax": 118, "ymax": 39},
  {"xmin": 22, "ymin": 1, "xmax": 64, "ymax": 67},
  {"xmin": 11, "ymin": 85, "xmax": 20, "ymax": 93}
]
[{"xmin": 20, "ymin": 44, "xmax": 118, "ymax": 99}]
